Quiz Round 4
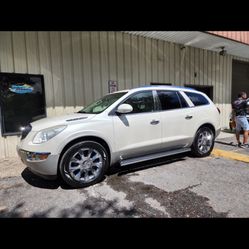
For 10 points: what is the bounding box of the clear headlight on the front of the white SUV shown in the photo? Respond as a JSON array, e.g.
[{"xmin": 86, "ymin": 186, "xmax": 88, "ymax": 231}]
[{"xmin": 33, "ymin": 125, "xmax": 67, "ymax": 144}]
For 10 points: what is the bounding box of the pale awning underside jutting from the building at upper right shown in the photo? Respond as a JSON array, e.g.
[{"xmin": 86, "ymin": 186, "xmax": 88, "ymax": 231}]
[{"xmin": 125, "ymin": 31, "xmax": 249, "ymax": 59}]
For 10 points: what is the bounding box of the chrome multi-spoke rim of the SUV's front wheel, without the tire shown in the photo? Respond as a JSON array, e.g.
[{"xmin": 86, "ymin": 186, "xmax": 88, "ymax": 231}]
[{"xmin": 68, "ymin": 148, "xmax": 103, "ymax": 183}]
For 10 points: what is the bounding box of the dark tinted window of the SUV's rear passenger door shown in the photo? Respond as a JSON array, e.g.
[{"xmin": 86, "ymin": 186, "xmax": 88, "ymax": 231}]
[{"xmin": 157, "ymin": 91, "xmax": 187, "ymax": 110}]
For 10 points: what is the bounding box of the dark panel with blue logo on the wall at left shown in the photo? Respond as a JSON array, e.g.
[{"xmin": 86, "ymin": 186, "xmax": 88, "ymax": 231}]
[{"xmin": 0, "ymin": 73, "xmax": 46, "ymax": 136}]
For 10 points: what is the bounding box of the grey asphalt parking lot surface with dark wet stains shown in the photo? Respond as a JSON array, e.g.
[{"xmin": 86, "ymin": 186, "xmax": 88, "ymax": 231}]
[{"xmin": 0, "ymin": 133, "xmax": 249, "ymax": 218}]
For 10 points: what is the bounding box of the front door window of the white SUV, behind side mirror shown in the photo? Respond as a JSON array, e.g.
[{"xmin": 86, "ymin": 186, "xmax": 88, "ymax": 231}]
[{"xmin": 124, "ymin": 91, "xmax": 154, "ymax": 113}]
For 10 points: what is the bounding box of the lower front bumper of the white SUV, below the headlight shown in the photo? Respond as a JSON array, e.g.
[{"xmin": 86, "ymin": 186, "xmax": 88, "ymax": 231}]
[{"xmin": 16, "ymin": 146, "xmax": 60, "ymax": 178}]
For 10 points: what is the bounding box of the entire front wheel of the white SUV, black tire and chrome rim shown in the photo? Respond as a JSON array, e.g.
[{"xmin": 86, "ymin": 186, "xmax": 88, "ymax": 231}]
[{"xmin": 59, "ymin": 141, "xmax": 109, "ymax": 188}]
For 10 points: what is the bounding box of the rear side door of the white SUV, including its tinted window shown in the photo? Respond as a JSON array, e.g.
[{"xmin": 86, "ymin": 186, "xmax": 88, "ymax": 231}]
[{"xmin": 157, "ymin": 90, "xmax": 196, "ymax": 150}]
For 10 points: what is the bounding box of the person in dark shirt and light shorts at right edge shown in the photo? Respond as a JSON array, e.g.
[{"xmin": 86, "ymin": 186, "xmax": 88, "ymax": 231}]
[{"xmin": 232, "ymin": 92, "xmax": 249, "ymax": 148}]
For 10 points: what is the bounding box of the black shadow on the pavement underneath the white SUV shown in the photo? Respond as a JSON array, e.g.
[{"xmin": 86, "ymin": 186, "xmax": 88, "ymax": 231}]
[{"xmin": 21, "ymin": 153, "xmax": 189, "ymax": 190}]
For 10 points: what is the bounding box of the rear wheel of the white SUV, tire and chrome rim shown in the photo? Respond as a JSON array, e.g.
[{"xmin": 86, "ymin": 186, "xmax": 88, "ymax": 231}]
[{"xmin": 191, "ymin": 127, "xmax": 214, "ymax": 157}]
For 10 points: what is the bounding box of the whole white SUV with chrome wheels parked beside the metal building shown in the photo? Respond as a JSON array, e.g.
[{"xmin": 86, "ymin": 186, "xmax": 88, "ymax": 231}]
[{"xmin": 17, "ymin": 86, "xmax": 220, "ymax": 187}]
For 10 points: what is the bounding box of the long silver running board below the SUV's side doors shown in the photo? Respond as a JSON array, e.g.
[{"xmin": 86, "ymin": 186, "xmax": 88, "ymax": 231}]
[{"xmin": 120, "ymin": 148, "xmax": 191, "ymax": 166}]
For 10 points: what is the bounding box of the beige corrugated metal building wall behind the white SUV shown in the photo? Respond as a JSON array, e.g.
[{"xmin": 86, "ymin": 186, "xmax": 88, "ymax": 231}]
[{"xmin": 0, "ymin": 32, "xmax": 243, "ymax": 157}]
